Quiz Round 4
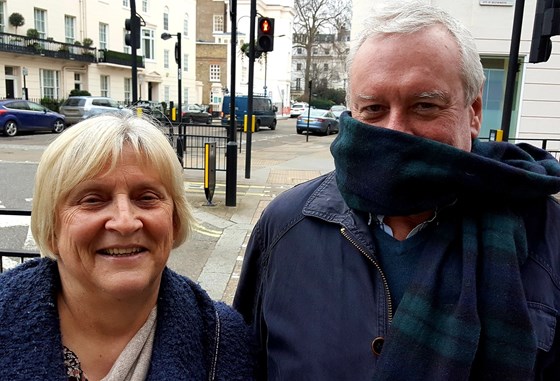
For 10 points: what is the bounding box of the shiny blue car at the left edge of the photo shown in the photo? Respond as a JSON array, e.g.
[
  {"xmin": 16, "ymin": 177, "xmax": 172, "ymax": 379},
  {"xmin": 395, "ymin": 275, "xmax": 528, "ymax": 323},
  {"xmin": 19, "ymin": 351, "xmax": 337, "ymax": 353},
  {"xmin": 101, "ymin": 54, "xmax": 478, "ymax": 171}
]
[{"xmin": 0, "ymin": 99, "xmax": 66, "ymax": 136}]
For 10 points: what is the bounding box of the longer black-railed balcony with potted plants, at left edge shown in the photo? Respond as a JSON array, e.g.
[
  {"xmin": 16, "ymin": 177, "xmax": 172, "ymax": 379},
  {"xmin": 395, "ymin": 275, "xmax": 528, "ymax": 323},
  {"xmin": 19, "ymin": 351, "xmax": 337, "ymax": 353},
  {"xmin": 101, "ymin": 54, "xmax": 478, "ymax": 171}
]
[{"xmin": 0, "ymin": 33, "xmax": 97, "ymax": 63}]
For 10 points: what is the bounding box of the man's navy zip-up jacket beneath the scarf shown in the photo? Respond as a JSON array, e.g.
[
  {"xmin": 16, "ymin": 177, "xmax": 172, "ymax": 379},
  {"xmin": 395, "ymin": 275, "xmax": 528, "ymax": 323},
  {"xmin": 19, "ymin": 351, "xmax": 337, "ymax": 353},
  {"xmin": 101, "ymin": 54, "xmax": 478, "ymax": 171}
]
[{"xmin": 234, "ymin": 173, "xmax": 560, "ymax": 381}]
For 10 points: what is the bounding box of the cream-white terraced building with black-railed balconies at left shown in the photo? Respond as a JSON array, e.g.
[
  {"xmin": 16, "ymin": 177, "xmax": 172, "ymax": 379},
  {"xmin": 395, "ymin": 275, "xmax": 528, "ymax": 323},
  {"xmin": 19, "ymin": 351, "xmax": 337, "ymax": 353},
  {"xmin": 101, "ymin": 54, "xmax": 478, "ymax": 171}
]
[{"xmin": 0, "ymin": 0, "xmax": 201, "ymax": 104}]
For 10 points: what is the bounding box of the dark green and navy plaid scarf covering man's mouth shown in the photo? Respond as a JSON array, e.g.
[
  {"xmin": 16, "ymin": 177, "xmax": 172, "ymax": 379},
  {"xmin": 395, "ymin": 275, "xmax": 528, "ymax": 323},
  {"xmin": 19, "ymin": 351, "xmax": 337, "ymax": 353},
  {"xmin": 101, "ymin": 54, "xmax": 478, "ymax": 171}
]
[{"xmin": 331, "ymin": 114, "xmax": 560, "ymax": 381}]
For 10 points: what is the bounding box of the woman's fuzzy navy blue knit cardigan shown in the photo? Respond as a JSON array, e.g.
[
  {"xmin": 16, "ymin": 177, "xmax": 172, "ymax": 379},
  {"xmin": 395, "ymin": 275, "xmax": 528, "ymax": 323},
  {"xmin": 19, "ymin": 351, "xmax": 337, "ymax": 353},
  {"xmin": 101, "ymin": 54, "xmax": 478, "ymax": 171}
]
[{"xmin": 0, "ymin": 258, "xmax": 254, "ymax": 381}]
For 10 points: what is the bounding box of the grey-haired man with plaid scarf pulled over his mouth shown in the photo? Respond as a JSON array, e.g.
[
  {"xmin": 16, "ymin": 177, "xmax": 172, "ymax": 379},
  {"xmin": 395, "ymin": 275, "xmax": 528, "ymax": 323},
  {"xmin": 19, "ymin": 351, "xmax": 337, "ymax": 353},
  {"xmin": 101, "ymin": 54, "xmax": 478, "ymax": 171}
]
[{"xmin": 234, "ymin": 2, "xmax": 560, "ymax": 381}]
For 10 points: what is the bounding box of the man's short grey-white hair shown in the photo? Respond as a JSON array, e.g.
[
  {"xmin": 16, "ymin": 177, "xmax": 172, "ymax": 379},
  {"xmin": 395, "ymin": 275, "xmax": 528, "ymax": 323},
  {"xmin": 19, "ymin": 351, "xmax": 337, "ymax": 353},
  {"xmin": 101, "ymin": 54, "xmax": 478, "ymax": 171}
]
[{"xmin": 346, "ymin": 0, "xmax": 484, "ymax": 104}]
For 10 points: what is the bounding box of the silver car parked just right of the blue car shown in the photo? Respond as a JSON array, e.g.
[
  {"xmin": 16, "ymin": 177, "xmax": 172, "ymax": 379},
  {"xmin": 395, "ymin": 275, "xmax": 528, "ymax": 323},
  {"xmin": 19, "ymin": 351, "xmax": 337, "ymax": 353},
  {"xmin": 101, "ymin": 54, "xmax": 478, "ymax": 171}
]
[{"xmin": 60, "ymin": 96, "xmax": 132, "ymax": 125}]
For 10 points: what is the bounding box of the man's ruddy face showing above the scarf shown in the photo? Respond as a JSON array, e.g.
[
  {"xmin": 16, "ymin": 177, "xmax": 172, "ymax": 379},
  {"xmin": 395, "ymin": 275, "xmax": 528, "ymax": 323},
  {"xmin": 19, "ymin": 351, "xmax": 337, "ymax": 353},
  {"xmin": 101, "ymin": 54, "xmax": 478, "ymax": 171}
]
[{"xmin": 349, "ymin": 26, "xmax": 482, "ymax": 151}]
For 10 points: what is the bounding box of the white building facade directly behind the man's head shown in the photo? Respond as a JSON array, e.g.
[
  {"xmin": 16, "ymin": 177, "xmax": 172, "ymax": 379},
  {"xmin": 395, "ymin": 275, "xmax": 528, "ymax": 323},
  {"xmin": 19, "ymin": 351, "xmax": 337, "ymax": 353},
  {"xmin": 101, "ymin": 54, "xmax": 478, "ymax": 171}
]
[{"xmin": 352, "ymin": 0, "xmax": 560, "ymax": 142}]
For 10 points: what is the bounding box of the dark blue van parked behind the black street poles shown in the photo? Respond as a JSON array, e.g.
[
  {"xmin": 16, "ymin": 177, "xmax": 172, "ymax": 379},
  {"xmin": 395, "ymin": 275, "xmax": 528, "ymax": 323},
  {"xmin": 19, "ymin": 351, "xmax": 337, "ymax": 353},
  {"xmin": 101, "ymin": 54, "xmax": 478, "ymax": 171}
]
[{"xmin": 222, "ymin": 95, "xmax": 278, "ymax": 131}]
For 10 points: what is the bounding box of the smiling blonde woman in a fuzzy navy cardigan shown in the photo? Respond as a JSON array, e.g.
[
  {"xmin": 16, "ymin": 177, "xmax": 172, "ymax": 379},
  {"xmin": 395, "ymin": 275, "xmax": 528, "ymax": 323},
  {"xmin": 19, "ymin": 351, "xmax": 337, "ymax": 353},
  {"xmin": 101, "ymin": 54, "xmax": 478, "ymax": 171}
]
[{"xmin": 0, "ymin": 114, "xmax": 253, "ymax": 381}]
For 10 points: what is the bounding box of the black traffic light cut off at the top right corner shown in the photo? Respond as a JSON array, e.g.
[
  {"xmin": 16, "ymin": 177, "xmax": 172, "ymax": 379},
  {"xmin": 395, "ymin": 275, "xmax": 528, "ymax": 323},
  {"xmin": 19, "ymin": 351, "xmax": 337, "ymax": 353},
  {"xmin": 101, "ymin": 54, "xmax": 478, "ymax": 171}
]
[{"xmin": 529, "ymin": 0, "xmax": 560, "ymax": 63}]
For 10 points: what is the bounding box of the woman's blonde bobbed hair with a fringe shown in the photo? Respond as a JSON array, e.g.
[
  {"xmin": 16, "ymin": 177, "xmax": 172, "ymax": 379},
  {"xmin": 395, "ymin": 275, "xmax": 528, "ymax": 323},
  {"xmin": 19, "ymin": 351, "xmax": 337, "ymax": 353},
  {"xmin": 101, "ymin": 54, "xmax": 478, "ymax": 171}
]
[{"xmin": 31, "ymin": 113, "xmax": 193, "ymax": 258}]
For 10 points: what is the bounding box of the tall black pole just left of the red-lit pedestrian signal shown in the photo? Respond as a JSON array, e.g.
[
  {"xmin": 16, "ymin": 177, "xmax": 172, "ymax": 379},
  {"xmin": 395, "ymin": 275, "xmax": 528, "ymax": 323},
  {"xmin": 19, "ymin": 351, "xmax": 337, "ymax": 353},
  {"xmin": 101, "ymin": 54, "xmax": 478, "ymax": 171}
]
[{"xmin": 222, "ymin": 0, "xmax": 237, "ymax": 206}]
